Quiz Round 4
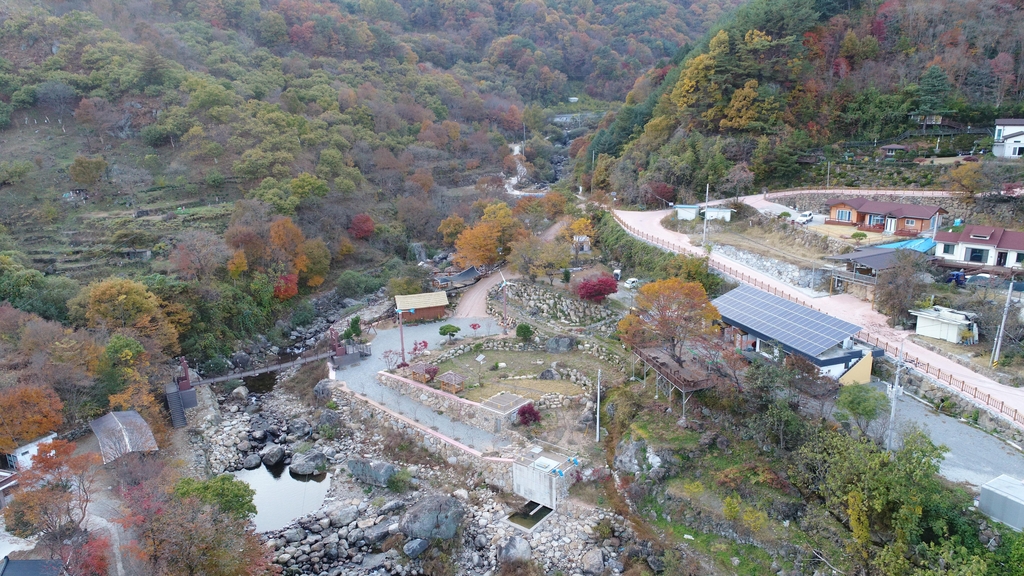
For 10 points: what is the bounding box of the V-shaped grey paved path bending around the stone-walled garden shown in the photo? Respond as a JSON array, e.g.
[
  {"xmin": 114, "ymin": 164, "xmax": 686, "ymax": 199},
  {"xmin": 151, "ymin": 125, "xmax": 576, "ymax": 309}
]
[{"xmin": 336, "ymin": 318, "xmax": 508, "ymax": 452}]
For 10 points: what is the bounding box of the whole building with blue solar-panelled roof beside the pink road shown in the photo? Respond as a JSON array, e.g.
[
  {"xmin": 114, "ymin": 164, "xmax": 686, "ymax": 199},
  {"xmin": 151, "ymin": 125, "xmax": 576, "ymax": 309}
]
[{"xmin": 712, "ymin": 285, "xmax": 883, "ymax": 384}]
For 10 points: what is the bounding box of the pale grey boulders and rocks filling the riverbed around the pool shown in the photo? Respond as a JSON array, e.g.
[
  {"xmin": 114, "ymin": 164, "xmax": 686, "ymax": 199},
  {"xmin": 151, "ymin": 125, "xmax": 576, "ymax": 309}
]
[{"xmin": 191, "ymin": 368, "xmax": 633, "ymax": 576}]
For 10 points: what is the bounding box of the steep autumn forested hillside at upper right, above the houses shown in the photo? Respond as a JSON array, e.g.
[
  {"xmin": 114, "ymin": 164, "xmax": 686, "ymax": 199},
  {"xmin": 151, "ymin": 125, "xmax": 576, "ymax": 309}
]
[{"xmin": 574, "ymin": 0, "xmax": 1024, "ymax": 201}]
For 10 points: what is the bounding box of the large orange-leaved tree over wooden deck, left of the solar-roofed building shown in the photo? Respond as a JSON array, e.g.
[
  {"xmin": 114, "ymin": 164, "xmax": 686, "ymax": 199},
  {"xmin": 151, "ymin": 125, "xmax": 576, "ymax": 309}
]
[{"xmin": 636, "ymin": 278, "xmax": 722, "ymax": 361}]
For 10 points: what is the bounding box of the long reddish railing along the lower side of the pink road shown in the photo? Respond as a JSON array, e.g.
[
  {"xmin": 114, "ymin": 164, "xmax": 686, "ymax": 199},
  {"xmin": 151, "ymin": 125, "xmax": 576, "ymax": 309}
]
[{"xmin": 611, "ymin": 212, "xmax": 1024, "ymax": 428}]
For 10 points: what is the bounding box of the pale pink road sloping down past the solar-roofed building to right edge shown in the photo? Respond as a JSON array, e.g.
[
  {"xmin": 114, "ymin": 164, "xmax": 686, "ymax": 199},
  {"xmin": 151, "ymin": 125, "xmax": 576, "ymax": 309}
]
[{"xmin": 615, "ymin": 204, "xmax": 1024, "ymax": 422}]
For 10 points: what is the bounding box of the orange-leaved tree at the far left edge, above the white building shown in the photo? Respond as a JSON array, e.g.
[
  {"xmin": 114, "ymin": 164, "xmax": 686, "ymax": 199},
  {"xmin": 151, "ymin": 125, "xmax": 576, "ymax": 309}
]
[{"xmin": 0, "ymin": 386, "xmax": 63, "ymax": 453}]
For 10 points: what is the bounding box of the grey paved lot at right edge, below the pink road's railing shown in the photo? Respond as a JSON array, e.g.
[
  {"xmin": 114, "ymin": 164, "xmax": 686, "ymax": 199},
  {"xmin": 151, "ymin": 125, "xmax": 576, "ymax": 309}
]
[{"xmin": 874, "ymin": 381, "xmax": 1024, "ymax": 488}]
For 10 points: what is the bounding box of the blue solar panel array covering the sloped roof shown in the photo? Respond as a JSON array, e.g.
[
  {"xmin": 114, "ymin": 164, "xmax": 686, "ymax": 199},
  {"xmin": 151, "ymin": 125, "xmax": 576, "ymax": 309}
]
[{"xmin": 712, "ymin": 285, "xmax": 860, "ymax": 356}]
